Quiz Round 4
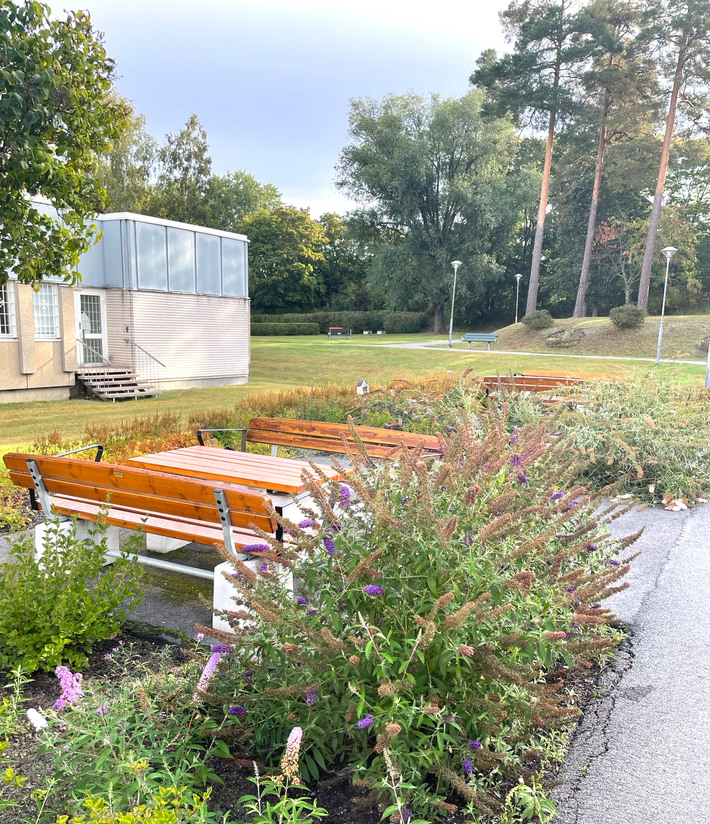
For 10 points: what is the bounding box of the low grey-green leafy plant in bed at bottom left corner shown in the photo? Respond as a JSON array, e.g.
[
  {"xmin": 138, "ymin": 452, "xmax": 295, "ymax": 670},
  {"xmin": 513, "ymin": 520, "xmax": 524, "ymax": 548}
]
[{"xmin": 39, "ymin": 643, "xmax": 229, "ymax": 824}]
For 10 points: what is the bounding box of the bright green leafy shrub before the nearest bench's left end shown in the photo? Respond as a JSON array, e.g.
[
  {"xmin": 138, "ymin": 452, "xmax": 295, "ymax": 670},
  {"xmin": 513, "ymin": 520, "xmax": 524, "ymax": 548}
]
[{"xmin": 0, "ymin": 518, "xmax": 142, "ymax": 674}]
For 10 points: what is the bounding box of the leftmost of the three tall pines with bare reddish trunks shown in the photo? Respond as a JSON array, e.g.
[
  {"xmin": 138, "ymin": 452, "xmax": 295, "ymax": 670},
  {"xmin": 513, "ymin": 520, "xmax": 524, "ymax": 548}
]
[{"xmin": 471, "ymin": 0, "xmax": 592, "ymax": 314}]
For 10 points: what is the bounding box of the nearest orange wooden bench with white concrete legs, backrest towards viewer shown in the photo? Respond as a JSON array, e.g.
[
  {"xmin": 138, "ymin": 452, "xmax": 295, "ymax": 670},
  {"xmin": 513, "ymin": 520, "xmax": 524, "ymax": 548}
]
[{"xmin": 4, "ymin": 452, "xmax": 286, "ymax": 631}]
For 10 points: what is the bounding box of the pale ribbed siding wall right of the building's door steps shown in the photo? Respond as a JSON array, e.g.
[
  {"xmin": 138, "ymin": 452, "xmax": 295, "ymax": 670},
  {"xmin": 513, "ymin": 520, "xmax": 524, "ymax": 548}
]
[{"xmin": 129, "ymin": 290, "xmax": 249, "ymax": 386}]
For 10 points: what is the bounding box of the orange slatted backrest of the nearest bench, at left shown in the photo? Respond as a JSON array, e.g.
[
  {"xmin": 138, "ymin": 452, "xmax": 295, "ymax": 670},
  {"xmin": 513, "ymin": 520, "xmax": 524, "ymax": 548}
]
[{"xmin": 4, "ymin": 452, "xmax": 277, "ymax": 532}]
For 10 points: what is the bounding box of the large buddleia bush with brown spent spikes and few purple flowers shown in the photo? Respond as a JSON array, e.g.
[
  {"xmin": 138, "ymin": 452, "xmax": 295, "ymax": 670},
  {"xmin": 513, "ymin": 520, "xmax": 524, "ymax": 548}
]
[{"xmin": 196, "ymin": 410, "xmax": 635, "ymax": 821}]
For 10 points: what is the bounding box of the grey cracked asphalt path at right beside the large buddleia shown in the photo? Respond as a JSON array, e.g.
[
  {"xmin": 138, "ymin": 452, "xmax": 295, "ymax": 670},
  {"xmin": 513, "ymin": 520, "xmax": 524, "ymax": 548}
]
[{"xmin": 554, "ymin": 504, "xmax": 710, "ymax": 824}]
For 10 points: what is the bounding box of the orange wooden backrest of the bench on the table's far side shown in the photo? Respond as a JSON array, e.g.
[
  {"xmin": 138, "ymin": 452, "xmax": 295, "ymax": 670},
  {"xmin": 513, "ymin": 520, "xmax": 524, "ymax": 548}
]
[{"xmin": 247, "ymin": 418, "xmax": 439, "ymax": 458}]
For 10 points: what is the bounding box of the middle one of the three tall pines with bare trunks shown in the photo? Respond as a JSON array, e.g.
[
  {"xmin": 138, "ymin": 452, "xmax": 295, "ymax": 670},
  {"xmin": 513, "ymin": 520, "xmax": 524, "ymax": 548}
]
[{"xmin": 572, "ymin": 0, "xmax": 657, "ymax": 318}]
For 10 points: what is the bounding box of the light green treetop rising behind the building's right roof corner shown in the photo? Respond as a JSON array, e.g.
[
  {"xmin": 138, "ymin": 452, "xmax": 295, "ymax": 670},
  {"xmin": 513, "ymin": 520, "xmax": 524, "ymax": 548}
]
[{"xmin": 205, "ymin": 170, "xmax": 281, "ymax": 232}]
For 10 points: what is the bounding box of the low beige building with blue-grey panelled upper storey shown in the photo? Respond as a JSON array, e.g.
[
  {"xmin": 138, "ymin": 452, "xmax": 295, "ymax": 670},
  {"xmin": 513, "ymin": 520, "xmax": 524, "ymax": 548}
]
[{"xmin": 0, "ymin": 212, "xmax": 250, "ymax": 403}]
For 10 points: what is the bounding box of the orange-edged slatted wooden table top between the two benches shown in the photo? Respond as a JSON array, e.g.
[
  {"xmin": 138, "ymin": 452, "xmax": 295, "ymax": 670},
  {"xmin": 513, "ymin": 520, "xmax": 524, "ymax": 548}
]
[{"xmin": 127, "ymin": 446, "xmax": 350, "ymax": 495}]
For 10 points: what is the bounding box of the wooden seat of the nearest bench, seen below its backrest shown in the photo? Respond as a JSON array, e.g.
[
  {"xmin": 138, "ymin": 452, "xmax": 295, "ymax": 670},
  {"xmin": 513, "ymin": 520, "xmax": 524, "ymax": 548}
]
[{"xmin": 50, "ymin": 496, "xmax": 268, "ymax": 546}]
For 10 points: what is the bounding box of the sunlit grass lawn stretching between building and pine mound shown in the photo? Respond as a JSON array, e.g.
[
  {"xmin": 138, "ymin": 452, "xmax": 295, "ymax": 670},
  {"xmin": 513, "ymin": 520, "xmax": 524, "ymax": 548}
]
[{"xmin": 0, "ymin": 315, "xmax": 710, "ymax": 453}]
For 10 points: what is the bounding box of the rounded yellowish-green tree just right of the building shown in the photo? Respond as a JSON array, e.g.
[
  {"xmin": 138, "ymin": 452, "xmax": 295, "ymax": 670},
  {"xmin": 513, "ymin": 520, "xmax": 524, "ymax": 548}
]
[{"xmin": 238, "ymin": 206, "xmax": 327, "ymax": 312}]
